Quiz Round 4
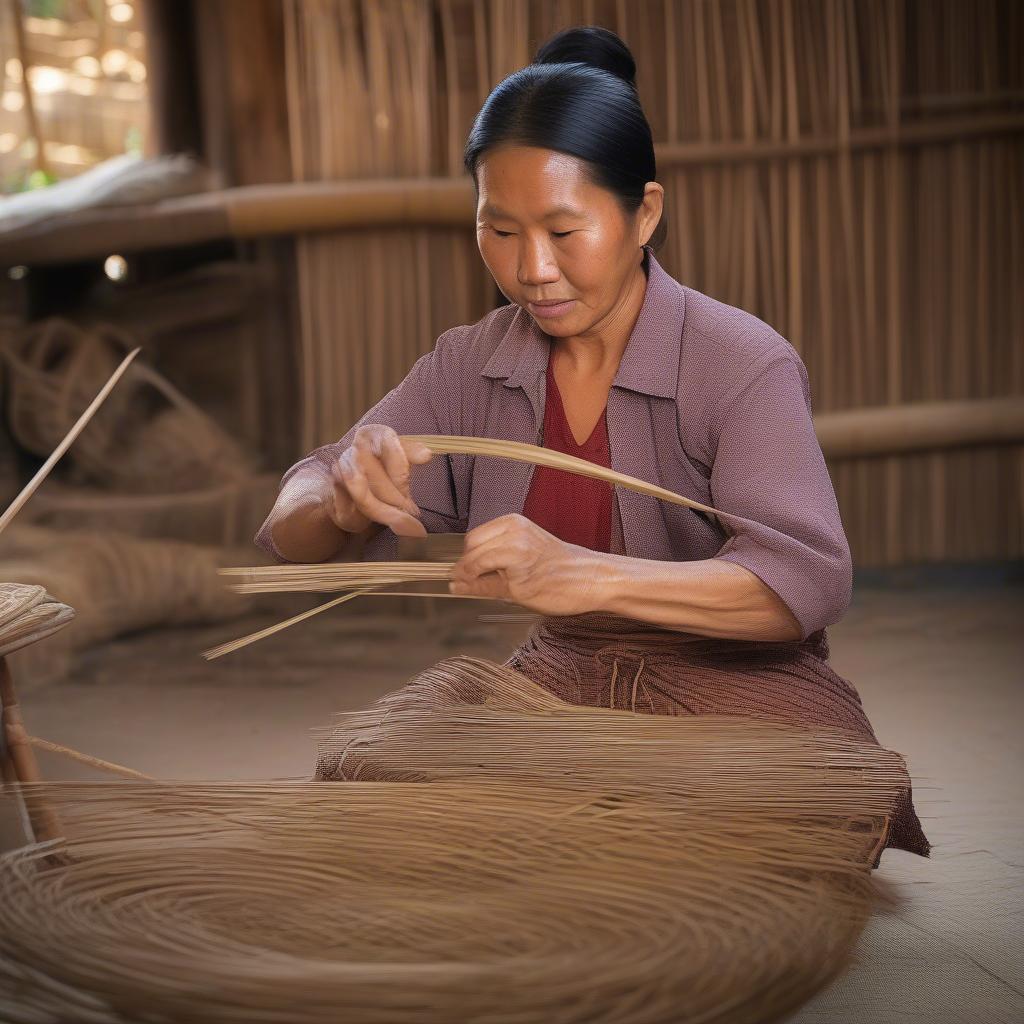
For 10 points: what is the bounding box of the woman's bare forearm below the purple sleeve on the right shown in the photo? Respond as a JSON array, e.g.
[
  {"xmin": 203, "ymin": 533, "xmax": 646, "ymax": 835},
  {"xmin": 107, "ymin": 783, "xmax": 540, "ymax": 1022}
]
[{"xmin": 587, "ymin": 555, "xmax": 801, "ymax": 641}]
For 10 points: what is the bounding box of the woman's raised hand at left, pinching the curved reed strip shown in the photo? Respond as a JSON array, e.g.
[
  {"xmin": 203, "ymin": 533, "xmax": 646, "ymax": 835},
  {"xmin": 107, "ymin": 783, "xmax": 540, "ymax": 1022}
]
[{"xmin": 327, "ymin": 423, "xmax": 433, "ymax": 537}]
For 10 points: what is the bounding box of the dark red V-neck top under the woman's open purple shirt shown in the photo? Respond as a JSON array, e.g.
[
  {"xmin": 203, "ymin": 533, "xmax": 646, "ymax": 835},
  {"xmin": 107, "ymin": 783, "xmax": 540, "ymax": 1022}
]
[{"xmin": 522, "ymin": 356, "xmax": 612, "ymax": 551}]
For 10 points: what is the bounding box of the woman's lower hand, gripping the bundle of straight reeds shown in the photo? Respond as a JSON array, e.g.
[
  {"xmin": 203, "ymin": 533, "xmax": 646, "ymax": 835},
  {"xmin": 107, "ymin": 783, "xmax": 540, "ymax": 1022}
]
[{"xmin": 449, "ymin": 515, "xmax": 601, "ymax": 615}]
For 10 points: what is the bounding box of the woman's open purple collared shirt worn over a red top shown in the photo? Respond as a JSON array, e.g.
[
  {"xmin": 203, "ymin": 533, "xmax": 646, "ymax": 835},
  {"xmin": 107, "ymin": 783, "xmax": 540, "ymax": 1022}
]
[{"xmin": 256, "ymin": 249, "xmax": 852, "ymax": 639}]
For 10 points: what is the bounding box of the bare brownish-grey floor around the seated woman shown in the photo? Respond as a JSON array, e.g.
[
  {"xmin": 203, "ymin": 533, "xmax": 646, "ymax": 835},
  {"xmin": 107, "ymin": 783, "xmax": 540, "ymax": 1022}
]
[{"xmin": 0, "ymin": 568, "xmax": 1024, "ymax": 1024}]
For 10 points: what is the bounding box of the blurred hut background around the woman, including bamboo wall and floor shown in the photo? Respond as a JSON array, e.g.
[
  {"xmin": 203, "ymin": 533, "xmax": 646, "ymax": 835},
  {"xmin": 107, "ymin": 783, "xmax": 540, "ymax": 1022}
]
[{"xmin": 0, "ymin": 0, "xmax": 1024, "ymax": 1024}]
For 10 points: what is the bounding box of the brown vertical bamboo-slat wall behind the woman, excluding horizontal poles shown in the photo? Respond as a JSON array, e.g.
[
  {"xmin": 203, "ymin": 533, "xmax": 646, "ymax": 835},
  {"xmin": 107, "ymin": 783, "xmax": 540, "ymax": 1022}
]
[{"xmin": 286, "ymin": 0, "xmax": 1024, "ymax": 565}]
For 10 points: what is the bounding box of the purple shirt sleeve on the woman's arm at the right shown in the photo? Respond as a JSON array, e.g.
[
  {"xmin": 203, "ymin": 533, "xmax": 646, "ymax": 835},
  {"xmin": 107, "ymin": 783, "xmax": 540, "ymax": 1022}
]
[{"xmin": 711, "ymin": 347, "xmax": 852, "ymax": 639}]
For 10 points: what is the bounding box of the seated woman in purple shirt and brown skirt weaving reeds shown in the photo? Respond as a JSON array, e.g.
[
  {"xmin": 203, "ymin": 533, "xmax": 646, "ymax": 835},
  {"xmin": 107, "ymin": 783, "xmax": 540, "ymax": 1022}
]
[{"xmin": 257, "ymin": 29, "xmax": 929, "ymax": 856}]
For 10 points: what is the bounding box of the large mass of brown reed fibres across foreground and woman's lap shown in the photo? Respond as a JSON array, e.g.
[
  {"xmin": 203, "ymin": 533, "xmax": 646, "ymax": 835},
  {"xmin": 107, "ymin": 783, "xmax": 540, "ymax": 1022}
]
[{"xmin": 0, "ymin": 658, "xmax": 906, "ymax": 1024}]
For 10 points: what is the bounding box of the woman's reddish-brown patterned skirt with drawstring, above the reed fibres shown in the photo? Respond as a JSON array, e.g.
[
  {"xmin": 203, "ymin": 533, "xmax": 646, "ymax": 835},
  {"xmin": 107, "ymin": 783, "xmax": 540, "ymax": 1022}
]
[{"xmin": 506, "ymin": 614, "xmax": 931, "ymax": 867}]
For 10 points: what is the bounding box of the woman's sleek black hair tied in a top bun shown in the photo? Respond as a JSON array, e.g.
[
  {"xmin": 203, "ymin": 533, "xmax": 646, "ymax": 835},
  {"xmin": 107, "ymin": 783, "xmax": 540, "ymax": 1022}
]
[{"xmin": 465, "ymin": 26, "xmax": 664, "ymax": 245}]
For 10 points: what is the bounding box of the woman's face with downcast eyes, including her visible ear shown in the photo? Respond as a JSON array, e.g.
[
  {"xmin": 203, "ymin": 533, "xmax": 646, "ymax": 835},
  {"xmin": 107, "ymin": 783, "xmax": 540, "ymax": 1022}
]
[{"xmin": 476, "ymin": 145, "xmax": 664, "ymax": 338}]
